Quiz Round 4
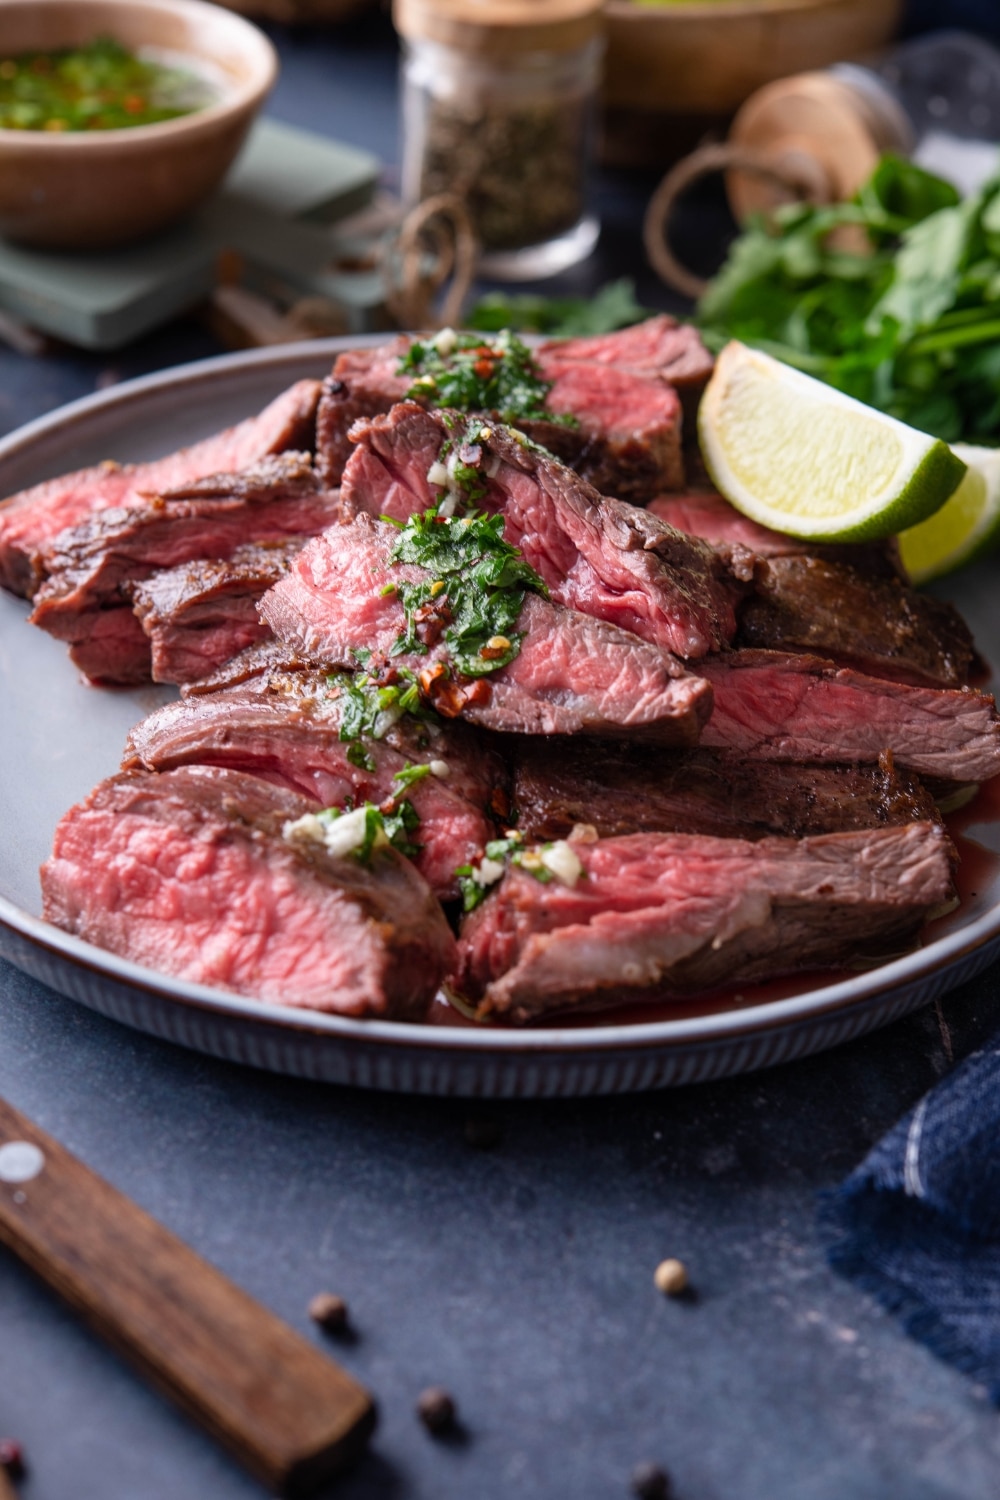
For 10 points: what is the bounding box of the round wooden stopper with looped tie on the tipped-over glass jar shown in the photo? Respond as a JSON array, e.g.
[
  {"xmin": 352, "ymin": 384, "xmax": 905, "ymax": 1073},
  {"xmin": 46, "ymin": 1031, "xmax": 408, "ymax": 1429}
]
[{"xmin": 643, "ymin": 65, "xmax": 913, "ymax": 297}]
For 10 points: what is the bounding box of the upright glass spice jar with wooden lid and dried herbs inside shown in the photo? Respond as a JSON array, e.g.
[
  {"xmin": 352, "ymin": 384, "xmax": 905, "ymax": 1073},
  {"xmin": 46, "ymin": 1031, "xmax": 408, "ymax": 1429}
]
[{"xmin": 393, "ymin": 0, "xmax": 604, "ymax": 281}]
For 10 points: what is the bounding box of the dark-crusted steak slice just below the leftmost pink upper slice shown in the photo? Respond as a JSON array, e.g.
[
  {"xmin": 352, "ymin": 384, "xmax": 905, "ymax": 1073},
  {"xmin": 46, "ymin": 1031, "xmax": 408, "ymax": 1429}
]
[{"xmin": 30, "ymin": 453, "xmax": 340, "ymax": 683}]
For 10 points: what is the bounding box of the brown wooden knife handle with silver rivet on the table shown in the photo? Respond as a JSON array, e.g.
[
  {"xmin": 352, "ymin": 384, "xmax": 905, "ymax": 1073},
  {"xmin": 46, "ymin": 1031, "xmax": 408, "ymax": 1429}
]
[{"xmin": 0, "ymin": 1100, "xmax": 375, "ymax": 1494}]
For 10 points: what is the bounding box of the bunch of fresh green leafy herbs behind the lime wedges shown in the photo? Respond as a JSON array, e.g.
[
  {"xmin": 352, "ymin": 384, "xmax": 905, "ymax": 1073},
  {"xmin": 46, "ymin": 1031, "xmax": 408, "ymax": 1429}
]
[{"xmin": 699, "ymin": 156, "xmax": 1000, "ymax": 443}]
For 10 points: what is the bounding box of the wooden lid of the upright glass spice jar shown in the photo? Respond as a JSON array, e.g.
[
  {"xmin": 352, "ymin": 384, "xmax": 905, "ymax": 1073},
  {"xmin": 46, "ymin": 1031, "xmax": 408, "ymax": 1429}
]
[{"xmin": 393, "ymin": 0, "xmax": 604, "ymax": 56}]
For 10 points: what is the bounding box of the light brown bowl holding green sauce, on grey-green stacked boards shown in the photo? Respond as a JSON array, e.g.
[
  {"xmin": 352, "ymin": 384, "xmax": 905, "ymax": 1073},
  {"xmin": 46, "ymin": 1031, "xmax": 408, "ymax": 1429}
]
[{"xmin": 0, "ymin": 0, "xmax": 277, "ymax": 249}]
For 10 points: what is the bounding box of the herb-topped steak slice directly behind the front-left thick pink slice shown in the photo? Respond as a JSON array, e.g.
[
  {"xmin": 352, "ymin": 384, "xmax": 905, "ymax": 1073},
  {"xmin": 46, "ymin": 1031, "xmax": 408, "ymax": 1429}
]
[{"xmin": 121, "ymin": 672, "xmax": 507, "ymax": 899}]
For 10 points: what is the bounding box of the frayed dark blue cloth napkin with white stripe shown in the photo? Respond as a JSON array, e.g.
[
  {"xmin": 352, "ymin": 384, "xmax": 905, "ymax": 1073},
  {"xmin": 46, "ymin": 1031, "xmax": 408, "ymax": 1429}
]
[{"xmin": 820, "ymin": 1043, "xmax": 1000, "ymax": 1404}]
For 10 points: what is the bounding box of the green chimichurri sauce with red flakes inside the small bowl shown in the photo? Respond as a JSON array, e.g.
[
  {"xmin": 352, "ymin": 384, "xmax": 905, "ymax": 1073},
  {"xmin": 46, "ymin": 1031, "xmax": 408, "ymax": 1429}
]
[{"xmin": 0, "ymin": 36, "xmax": 217, "ymax": 131}]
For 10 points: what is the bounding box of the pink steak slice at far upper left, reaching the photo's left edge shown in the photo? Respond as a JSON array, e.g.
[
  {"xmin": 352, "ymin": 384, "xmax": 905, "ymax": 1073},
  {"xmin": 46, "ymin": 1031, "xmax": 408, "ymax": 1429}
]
[{"xmin": 0, "ymin": 380, "xmax": 319, "ymax": 597}]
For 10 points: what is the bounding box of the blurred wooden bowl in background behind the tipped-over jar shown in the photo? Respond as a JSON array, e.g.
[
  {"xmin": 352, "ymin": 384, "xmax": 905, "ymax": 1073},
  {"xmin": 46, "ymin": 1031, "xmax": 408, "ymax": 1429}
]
[{"xmin": 604, "ymin": 0, "xmax": 903, "ymax": 117}]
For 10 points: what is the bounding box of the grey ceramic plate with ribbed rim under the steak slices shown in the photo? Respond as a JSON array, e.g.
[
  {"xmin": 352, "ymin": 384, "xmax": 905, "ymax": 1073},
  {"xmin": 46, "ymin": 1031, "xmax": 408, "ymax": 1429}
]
[{"xmin": 0, "ymin": 339, "xmax": 1000, "ymax": 1097}]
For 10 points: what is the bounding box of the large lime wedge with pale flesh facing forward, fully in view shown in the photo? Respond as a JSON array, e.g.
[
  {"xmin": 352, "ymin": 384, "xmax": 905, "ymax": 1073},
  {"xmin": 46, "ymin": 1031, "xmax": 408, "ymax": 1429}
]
[{"xmin": 699, "ymin": 342, "xmax": 966, "ymax": 542}]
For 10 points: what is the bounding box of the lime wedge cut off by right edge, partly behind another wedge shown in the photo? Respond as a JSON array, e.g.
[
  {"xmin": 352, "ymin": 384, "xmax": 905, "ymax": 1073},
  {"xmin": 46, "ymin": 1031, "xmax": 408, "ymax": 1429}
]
[{"xmin": 900, "ymin": 443, "xmax": 1000, "ymax": 584}]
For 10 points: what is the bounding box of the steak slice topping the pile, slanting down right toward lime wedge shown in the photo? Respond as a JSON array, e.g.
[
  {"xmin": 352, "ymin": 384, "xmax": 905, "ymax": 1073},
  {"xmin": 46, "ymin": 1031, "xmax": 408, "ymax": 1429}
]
[{"xmin": 342, "ymin": 402, "xmax": 743, "ymax": 660}]
